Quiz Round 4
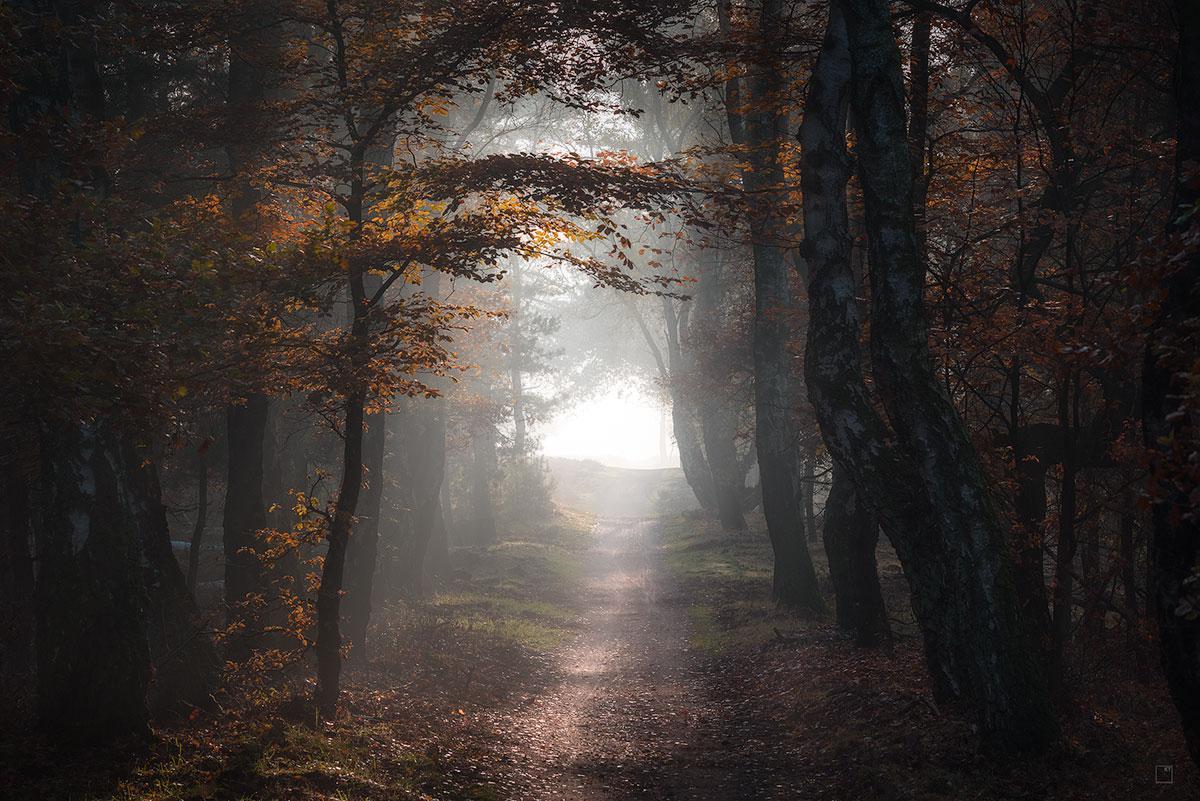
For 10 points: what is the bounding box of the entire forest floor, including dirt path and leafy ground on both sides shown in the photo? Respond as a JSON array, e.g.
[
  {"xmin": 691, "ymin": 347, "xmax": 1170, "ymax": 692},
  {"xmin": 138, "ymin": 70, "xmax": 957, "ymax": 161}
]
[{"xmin": 0, "ymin": 462, "xmax": 1200, "ymax": 801}]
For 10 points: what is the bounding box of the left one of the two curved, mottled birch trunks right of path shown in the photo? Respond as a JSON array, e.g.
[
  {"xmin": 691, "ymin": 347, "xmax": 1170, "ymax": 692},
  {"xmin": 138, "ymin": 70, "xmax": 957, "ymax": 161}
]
[{"xmin": 800, "ymin": 2, "xmax": 966, "ymax": 705}]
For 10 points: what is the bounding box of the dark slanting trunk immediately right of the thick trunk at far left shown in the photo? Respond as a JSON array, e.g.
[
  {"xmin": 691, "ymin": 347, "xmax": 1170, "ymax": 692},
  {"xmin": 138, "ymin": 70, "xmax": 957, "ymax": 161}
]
[{"xmin": 121, "ymin": 440, "xmax": 221, "ymax": 716}]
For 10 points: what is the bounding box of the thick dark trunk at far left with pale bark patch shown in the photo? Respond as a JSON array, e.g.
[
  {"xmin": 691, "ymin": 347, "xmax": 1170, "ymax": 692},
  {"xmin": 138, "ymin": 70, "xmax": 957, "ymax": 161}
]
[{"xmin": 35, "ymin": 424, "xmax": 150, "ymax": 743}]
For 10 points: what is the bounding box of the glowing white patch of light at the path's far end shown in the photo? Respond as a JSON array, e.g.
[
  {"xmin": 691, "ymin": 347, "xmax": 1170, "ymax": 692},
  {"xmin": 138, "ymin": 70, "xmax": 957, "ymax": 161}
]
[{"xmin": 541, "ymin": 389, "xmax": 679, "ymax": 468}]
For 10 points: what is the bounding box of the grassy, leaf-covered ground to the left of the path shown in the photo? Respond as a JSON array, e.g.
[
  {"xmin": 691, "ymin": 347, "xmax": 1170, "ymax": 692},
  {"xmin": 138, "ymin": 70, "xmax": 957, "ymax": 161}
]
[{"xmin": 0, "ymin": 513, "xmax": 592, "ymax": 801}]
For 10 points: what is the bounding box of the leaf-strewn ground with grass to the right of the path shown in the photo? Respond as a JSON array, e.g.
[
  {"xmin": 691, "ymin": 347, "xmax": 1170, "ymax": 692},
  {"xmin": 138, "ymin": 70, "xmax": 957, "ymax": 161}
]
[{"xmin": 662, "ymin": 517, "xmax": 1200, "ymax": 801}]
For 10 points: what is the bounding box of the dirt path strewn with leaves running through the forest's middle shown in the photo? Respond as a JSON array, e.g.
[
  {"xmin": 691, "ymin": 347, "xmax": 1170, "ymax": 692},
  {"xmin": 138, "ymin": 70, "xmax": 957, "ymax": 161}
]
[{"xmin": 498, "ymin": 518, "xmax": 761, "ymax": 801}]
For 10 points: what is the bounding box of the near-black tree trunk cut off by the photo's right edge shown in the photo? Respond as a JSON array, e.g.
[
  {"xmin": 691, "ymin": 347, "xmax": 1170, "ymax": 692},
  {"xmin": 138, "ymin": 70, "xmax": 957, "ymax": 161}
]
[{"xmin": 1142, "ymin": 0, "xmax": 1200, "ymax": 765}]
